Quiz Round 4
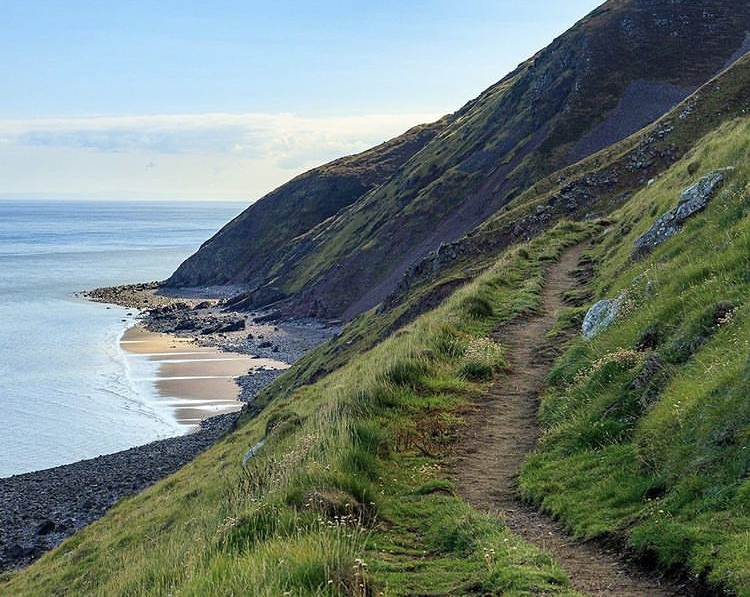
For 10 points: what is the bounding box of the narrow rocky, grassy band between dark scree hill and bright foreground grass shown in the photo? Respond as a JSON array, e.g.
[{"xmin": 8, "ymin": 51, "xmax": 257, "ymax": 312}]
[{"xmin": 261, "ymin": 50, "xmax": 750, "ymax": 401}]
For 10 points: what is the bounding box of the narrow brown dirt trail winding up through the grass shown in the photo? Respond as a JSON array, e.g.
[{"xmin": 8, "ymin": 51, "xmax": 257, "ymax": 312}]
[{"xmin": 455, "ymin": 246, "xmax": 685, "ymax": 597}]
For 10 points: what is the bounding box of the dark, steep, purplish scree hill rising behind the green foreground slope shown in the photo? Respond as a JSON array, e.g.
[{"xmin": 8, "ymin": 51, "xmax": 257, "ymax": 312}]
[{"xmin": 170, "ymin": 0, "xmax": 750, "ymax": 318}]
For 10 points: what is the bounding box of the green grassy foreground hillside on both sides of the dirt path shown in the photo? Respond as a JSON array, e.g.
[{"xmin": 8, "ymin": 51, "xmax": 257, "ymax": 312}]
[{"xmin": 7, "ymin": 45, "xmax": 750, "ymax": 597}]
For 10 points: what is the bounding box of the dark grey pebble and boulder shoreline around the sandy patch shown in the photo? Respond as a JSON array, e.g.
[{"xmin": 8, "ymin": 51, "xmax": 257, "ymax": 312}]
[{"xmin": 0, "ymin": 283, "xmax": 338, "ymax": 573}]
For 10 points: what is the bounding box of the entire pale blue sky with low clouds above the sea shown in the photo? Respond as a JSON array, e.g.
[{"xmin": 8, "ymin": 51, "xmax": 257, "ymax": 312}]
[{"xmin": 0, "ymin": 0, "xmax": 602, "ymax": 202}]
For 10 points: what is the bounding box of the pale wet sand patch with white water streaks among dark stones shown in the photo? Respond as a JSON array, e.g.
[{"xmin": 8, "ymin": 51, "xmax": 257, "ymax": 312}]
[{"xmin": 120, "ymin": 326, "xmax": 289, "ymax": 427}]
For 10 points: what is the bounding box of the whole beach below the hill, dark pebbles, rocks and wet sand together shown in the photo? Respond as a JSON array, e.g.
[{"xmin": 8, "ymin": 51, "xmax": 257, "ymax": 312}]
[{"xmin": 0, "ymin": 283, "xmax": 337, "ymax": 572}]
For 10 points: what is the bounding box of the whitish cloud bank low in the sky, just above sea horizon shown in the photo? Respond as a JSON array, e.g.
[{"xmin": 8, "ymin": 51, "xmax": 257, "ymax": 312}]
[{"xmin": 0, "ymin": 113, "xmax": 438, "ymax": 200}]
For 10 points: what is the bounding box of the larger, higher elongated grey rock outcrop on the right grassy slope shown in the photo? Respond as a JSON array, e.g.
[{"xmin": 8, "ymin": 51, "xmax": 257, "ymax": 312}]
[{"xmin": 634, "ymin": 169, "xmax": 727, "ymax": 255}]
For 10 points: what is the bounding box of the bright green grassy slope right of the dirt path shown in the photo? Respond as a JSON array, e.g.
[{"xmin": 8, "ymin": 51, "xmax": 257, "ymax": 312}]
[{"xmin": 522, "ymin": 119, "xmax": 750, "ymax": 595}]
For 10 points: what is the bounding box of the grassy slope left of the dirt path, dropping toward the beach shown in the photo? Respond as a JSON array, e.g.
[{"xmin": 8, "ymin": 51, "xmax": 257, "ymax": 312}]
[{"xmin": 0, "ymin": 224, "xmax": 592, "ymax": 596}]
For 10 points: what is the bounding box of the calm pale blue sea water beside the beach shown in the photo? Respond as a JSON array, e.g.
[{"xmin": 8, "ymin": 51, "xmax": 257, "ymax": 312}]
[{"xmin": 0, "ymin": 200, "xmax": 244, "ymax": 477}]
